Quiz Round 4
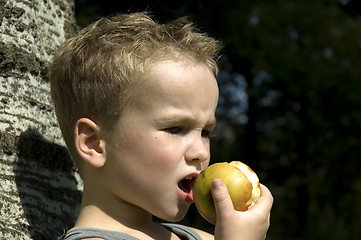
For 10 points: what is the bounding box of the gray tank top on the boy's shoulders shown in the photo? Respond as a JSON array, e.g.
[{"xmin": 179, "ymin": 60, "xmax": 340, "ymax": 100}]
[{"xmin": 63, "ymin": 223, "xmax": 202, "ymax": 240}]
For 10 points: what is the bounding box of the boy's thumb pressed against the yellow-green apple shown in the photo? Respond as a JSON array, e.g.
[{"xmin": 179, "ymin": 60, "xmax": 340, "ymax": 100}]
[{"xmin": 212, "ymin": 179, "xmax": 234, "ymax": 223}]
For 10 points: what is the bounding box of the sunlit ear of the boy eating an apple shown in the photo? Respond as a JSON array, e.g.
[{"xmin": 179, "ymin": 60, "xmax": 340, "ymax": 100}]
[{"xmin": 74, "ymin": 118, "xmax": 106, "ymax": 168}]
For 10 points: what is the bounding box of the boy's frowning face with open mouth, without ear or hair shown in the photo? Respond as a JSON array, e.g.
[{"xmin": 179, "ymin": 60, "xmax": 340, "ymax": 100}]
[{"xmin": 103, "ymin": 60, "xmax": 218, "ymax": 221}]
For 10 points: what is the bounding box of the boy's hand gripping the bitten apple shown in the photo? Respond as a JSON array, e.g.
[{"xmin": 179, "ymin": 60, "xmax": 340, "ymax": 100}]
[{"xmin": 212, "ymin": 179, "xmax": 273, "ymax": 240}]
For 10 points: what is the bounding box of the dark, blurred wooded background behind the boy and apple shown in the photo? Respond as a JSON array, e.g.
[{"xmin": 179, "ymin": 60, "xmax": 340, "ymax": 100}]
[{"xmin": 75, "ymin": 0, "xmax": 361, "ymax": 240}]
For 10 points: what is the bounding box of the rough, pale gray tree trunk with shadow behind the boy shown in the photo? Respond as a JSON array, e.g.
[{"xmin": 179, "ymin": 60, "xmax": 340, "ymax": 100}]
[{"xmin": 0, "ymin": 0, "xmax": 81, "ymax": 239}]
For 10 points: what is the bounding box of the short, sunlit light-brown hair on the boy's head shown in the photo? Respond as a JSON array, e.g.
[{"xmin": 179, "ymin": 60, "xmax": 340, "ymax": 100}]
[{"xmin": 50, "ymin": 13, "xmax": 221, "ymax": 164}]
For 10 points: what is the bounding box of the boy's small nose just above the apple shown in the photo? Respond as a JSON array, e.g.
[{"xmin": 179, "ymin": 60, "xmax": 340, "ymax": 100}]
[{"xmin": 185, "ymin": 133, "xmax": 210, "ymax": 163}]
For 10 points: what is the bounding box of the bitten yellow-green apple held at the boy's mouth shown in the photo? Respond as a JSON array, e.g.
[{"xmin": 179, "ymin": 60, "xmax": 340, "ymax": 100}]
[{"xmin": 193, "ymin": 161, "xmax": 261, "ymax": 224}]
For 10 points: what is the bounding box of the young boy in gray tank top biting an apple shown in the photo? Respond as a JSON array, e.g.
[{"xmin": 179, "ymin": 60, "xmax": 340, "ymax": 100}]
[{"xmin": 50, "ymin": 13, "xmax": 273, "ymax": 240}]
